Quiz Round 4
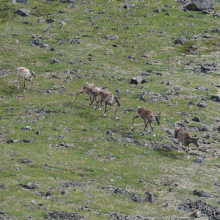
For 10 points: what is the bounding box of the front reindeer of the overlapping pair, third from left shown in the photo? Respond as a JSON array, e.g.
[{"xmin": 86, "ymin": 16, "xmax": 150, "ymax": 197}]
[{"xmin": 95, "ymin": 89, "xmax": 121, "ymax": 120}]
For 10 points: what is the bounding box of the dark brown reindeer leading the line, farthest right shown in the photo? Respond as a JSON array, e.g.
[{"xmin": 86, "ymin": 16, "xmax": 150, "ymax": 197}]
[{"xmin": 174, "ymin": 128, "xmax": 199, "ymax": 158}]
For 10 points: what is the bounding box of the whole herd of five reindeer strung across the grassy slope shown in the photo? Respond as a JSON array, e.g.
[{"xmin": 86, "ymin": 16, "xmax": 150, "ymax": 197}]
[{"xmin": 17, "ymin": 67, "xmax": 199, "ymax": 158}]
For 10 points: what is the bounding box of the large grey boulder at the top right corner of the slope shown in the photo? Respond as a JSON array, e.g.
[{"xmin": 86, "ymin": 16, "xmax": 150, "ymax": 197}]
[{"xmin": 184, "ymin": 0, "xmax": 215, "ymax": 11}]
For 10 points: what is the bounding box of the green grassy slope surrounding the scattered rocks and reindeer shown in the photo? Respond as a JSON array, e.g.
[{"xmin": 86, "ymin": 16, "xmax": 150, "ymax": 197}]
[{"xmin": 0, "ymin": 0, "xmax": 219, "ymax": 219}]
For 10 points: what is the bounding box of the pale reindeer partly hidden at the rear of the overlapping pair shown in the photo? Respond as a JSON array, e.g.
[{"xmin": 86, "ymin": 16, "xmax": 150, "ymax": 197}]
[{"xmin": 73, "ymin": 82, "xmax": 100, "ymax": 107}]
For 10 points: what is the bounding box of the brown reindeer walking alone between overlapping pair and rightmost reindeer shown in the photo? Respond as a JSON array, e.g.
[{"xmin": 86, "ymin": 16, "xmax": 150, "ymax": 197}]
[{"xmin": 131, "ymin": 106, "xmax": 161, "ymax": 136}]
